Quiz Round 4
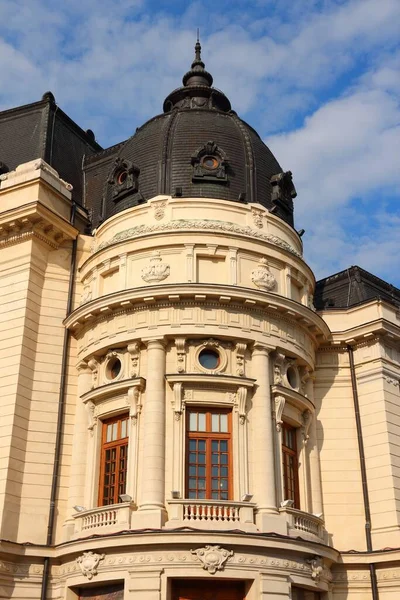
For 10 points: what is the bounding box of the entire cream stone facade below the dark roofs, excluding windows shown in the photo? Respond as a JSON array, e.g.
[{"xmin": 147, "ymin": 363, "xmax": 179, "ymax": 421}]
[{"xmin": 0, "ymin": 161, "xmax": 400, "ymax": 600}]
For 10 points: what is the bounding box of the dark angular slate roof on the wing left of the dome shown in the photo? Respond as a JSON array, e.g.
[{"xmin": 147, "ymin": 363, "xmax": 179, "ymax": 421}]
[{"xmin": 0, "ymin": 92, "xmax": 102, "ymax": 204}]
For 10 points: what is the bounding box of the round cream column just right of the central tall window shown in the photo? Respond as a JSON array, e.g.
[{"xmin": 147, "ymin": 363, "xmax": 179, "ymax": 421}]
[{"xmin": 251, "ymin": 344, "xmax": 277, "ymax": 514}]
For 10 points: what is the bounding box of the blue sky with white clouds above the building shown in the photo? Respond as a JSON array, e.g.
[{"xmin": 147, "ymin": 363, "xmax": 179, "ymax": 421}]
[{"xmin": 0, "ymin": 0, "xmax": 400, "ymax": 287}]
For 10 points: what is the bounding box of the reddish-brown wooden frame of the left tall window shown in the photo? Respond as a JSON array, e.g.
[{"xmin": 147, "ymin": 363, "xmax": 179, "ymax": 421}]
[{"xmin": 98, "ymin": 413, "xmax": 129, "ymax": 506}]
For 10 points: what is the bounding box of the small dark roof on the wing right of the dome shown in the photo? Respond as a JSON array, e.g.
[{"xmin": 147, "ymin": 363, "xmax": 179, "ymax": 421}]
[{"xmin": 314, "ymin": 266, "xmax": 400, "ymax": 310}]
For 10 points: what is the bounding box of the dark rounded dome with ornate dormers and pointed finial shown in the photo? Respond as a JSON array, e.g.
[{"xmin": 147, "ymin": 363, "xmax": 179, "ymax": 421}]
[{"xmin": 103, "ymin": 41, "xmax": 296, "ymax": 226}]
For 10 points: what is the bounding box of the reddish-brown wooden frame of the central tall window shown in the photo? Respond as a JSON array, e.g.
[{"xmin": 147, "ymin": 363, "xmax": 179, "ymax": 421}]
[{"xmin": 185, "ymin": 406, "xmax": 233, "ymax": 502}]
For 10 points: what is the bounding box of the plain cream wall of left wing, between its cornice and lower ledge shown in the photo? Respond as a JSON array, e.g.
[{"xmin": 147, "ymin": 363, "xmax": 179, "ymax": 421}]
[{"xmin": 1, "ymin": 241, "xmax": 71, "ymax": 543}]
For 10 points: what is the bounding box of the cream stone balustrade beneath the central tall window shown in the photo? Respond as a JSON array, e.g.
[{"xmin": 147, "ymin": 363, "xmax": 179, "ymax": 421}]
[{"xmin": 166, "ymin": 500, "xmax": 256, "ymax": 531}]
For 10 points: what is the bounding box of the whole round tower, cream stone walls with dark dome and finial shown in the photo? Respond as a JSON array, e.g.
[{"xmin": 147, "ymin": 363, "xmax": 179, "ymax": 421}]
[{"xmin": 59, "ymin": 42, "xmax": 337, "ymax": 600}]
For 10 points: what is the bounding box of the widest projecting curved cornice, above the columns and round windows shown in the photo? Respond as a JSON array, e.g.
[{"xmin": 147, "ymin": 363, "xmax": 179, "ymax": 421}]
[{"xmin": 64, "ymin": 283, "xmax": 330, "ymax": 340}]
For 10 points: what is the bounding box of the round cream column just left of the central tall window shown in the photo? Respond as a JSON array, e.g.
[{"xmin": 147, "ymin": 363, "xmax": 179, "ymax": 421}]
[{"xmin": 139, "ymin": 339, "xmax": 165, "ymax": 511}]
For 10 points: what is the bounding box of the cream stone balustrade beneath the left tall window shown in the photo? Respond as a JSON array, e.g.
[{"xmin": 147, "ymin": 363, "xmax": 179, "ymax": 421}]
[{"xmin": 73, "ymin": 502, "xmax": 136, "ymax": 539}]
